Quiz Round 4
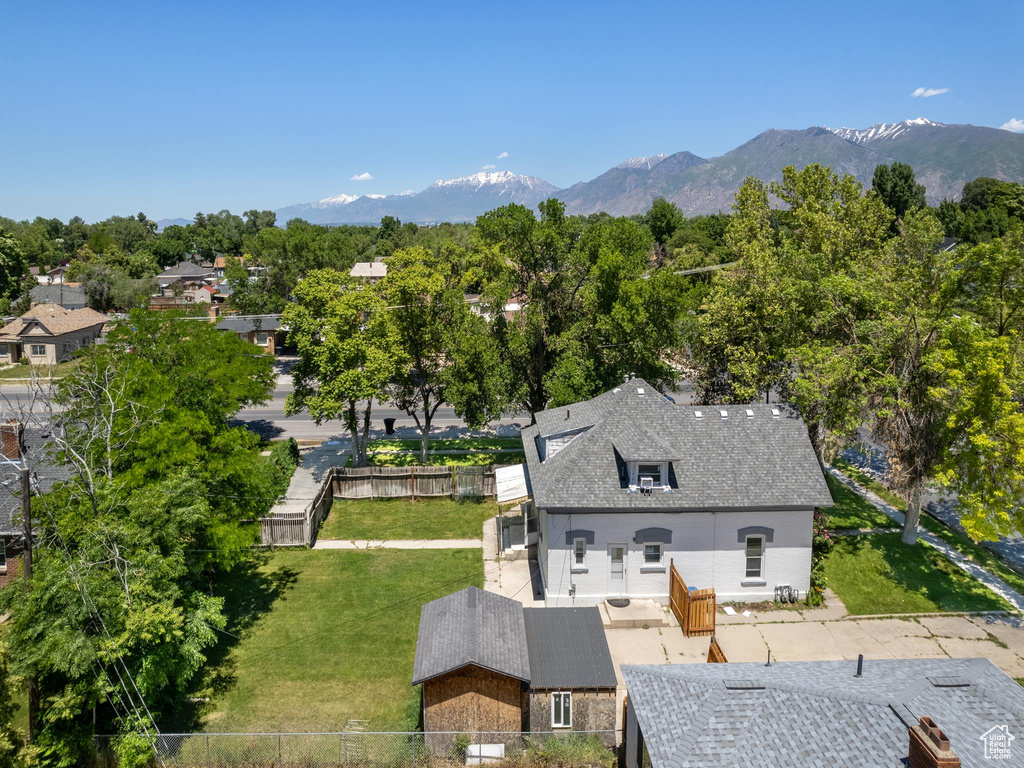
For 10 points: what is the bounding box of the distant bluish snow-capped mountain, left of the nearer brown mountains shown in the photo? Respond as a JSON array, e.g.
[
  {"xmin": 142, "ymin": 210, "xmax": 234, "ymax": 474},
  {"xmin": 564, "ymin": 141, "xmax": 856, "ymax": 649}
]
[{"xmin": 276, "ymin": 171, "xmax": 558, "ymax": 224}]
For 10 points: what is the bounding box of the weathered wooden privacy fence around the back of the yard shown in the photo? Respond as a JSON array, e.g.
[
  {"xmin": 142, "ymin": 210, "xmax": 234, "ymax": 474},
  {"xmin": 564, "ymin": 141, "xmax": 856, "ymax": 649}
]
[{"xmin": 259, "ymin": 465, "xmax": 503, "ymax": 547}]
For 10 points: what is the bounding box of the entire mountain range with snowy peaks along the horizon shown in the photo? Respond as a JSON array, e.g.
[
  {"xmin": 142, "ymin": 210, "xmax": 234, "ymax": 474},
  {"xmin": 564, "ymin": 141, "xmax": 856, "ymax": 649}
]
[{"xmin": 276, "ymin": 118, "xmax": 1024, "ymax": 224}]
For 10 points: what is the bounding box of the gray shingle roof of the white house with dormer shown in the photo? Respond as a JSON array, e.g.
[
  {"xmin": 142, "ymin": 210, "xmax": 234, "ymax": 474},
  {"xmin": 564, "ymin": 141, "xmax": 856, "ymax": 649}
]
[{"xmin": 522, "ymin": 379, "xmax": 833, "ymax": 511}]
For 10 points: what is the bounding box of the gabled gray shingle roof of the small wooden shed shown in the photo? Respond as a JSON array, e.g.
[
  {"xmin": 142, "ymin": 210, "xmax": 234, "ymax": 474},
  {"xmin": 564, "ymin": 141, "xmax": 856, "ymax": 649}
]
[{"xmin": 413, "ymin": 587, "xmax": 529, "ymax": 685}]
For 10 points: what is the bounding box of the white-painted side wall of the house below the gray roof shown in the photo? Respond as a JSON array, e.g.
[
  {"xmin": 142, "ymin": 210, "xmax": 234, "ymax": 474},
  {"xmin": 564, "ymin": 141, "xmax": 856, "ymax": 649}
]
[{"xmin": 541, "ymin": 509, "xmax": 813, "ymax": 606}]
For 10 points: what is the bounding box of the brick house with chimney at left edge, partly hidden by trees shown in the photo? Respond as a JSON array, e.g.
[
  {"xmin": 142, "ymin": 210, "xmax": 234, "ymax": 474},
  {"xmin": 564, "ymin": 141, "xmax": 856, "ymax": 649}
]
[{"xmin": 0, "ymin": 422, "xmax": 70, "ymax": 588}]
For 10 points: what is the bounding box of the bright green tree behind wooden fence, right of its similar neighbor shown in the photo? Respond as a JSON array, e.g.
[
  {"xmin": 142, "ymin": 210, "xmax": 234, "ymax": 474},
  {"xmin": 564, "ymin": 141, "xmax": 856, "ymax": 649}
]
[{"xmin": 379, "ymin": 248, "xmax": 498, "ymax": 464}]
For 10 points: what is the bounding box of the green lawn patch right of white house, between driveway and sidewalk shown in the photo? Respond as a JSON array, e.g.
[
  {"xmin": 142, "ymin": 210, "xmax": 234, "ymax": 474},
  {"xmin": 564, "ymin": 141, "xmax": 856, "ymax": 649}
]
[{"xmin": 825, "ymin": 534, "xmax": 1011, "ymax": 615}]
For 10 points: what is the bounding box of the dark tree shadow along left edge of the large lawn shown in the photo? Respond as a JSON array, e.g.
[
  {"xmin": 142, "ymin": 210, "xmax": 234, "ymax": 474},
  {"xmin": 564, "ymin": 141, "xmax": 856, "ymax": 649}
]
[{"xmin": 161, "ymin": 552, "xmax": 299, "ymax": 733}]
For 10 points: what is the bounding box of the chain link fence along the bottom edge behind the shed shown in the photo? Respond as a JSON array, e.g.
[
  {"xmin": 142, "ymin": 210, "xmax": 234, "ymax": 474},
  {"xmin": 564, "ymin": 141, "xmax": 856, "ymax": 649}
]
[{"xmin": 96, "ymin": 731, "xmax": 618, "ymax": 768}]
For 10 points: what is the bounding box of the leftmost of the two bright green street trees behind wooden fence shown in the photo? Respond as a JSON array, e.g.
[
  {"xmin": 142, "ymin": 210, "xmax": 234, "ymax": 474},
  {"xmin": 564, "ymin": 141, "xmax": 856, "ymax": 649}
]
[{"xmin": 282, "ymin": 269, "xmax": 400, "ymax": 467}]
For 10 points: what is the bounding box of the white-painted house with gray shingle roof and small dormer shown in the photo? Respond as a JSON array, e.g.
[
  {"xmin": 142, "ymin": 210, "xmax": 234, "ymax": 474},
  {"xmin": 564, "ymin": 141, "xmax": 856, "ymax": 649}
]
[{"xmin": 522, "ymin": 379, "xmax": 833, "ymax": 605}]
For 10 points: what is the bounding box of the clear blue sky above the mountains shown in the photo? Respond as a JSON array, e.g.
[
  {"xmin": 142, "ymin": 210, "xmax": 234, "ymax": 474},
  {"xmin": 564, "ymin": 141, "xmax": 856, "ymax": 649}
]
[{"xmin": 0, "ymin": 0, "xmax": 1024, "ymax": 220}]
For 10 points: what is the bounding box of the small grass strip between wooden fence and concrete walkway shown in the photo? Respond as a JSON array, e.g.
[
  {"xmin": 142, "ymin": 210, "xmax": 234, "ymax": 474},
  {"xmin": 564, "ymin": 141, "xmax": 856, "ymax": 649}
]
[{"xmin": 319, "ymin": 497, "xmax": 498, "ymax": 539}]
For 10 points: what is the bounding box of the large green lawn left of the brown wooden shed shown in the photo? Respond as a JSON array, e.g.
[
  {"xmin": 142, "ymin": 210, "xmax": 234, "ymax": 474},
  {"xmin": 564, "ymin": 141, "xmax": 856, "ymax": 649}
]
[{"xmin": 180, "ymin": 549, "xmax": 483, "ymax": 732}]
